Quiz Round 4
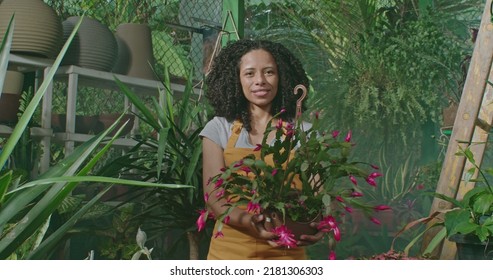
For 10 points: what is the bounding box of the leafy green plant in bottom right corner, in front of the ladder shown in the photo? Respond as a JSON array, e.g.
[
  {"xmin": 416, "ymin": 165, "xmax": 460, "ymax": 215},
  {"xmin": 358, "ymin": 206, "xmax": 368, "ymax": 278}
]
[{"xmin": 396, "ymin": 143, "xmax": 493, "ymax": 259}]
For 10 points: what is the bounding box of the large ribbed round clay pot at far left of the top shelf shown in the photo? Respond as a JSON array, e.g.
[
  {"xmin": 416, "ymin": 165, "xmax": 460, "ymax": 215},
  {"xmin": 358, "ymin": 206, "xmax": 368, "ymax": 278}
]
[{"xmin": 0, "ymin": 0, "xmax": 63, "ymax": 58}]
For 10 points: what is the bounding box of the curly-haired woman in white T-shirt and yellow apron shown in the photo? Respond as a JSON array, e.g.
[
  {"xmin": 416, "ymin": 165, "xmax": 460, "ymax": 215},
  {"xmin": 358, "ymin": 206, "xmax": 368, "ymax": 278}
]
[{"xmin": 201, "ymin": 40, "xmax": 323, "ymax": 259}]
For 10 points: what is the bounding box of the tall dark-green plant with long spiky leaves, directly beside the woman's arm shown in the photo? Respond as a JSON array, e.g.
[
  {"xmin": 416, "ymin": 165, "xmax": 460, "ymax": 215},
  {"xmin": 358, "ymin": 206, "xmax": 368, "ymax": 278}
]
[{"xmin": 89, "ymin": 66, "xmax": 208, "ymax": 259}]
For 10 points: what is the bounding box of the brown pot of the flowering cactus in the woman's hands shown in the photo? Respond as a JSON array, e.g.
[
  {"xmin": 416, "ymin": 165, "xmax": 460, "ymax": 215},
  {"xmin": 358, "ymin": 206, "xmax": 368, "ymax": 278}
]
[{"xmin": 264, "ymin": 210, "xmax": 321, "ymax": 240}]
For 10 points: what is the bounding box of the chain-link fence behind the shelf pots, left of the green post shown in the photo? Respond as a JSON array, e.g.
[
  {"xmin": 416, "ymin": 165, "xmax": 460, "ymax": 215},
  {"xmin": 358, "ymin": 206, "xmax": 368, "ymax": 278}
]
[{"xmin": 45, "ymin": 0, "xmax": 222, "ymax": 80}]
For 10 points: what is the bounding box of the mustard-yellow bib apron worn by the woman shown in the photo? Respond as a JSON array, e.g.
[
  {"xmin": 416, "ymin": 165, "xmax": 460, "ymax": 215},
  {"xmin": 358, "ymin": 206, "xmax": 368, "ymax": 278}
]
[{"xmin": 207, "ymin": 121, "xmax": 306, "ymax": 260}]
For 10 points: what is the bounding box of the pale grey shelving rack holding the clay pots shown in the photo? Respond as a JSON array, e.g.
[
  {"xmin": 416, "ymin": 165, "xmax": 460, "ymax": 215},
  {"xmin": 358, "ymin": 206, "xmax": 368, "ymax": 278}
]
[{"xmin": 4, "ymin": 54, "xmax": 196, "ymax": 173}]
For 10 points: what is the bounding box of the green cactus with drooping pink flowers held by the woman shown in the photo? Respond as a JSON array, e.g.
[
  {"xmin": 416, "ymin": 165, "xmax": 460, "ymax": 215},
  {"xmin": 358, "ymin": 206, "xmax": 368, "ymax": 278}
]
[{"xmin": 197, "ymin": 86, "xmax": 389, "ymax": 258}]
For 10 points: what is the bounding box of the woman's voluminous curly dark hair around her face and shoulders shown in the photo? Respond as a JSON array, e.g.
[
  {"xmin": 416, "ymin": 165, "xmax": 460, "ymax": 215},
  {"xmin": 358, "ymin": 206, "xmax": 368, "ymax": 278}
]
[{"xmin": 205, "ymin": 39, "xmax": 309, "ymax": 131}]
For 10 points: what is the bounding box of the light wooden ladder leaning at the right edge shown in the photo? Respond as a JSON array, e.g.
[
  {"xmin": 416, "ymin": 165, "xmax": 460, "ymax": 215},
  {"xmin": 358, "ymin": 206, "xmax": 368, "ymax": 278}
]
[{"xmin": 422, "ymin": 0, "xmax": 493, "ymax": 259}]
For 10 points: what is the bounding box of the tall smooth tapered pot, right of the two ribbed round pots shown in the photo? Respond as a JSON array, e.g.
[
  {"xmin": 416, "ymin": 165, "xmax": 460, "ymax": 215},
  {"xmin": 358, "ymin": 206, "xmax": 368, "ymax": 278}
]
[{"xmin": 114, "ymin": 23, "xmax": 156, "ymax": 80}]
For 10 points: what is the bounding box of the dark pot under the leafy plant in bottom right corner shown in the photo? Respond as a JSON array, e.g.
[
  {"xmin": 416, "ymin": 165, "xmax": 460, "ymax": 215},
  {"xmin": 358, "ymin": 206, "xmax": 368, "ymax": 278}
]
[{"xmin": 449, "ymin": 234, "xmax": 493, "ymax": 260}]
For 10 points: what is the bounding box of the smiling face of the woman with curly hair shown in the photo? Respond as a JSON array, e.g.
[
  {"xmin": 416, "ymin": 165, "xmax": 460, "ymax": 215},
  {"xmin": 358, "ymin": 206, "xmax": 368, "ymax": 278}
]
[{"xmin": 240, "ymin": 49, "xmax": 279, "ymax": 110}]
